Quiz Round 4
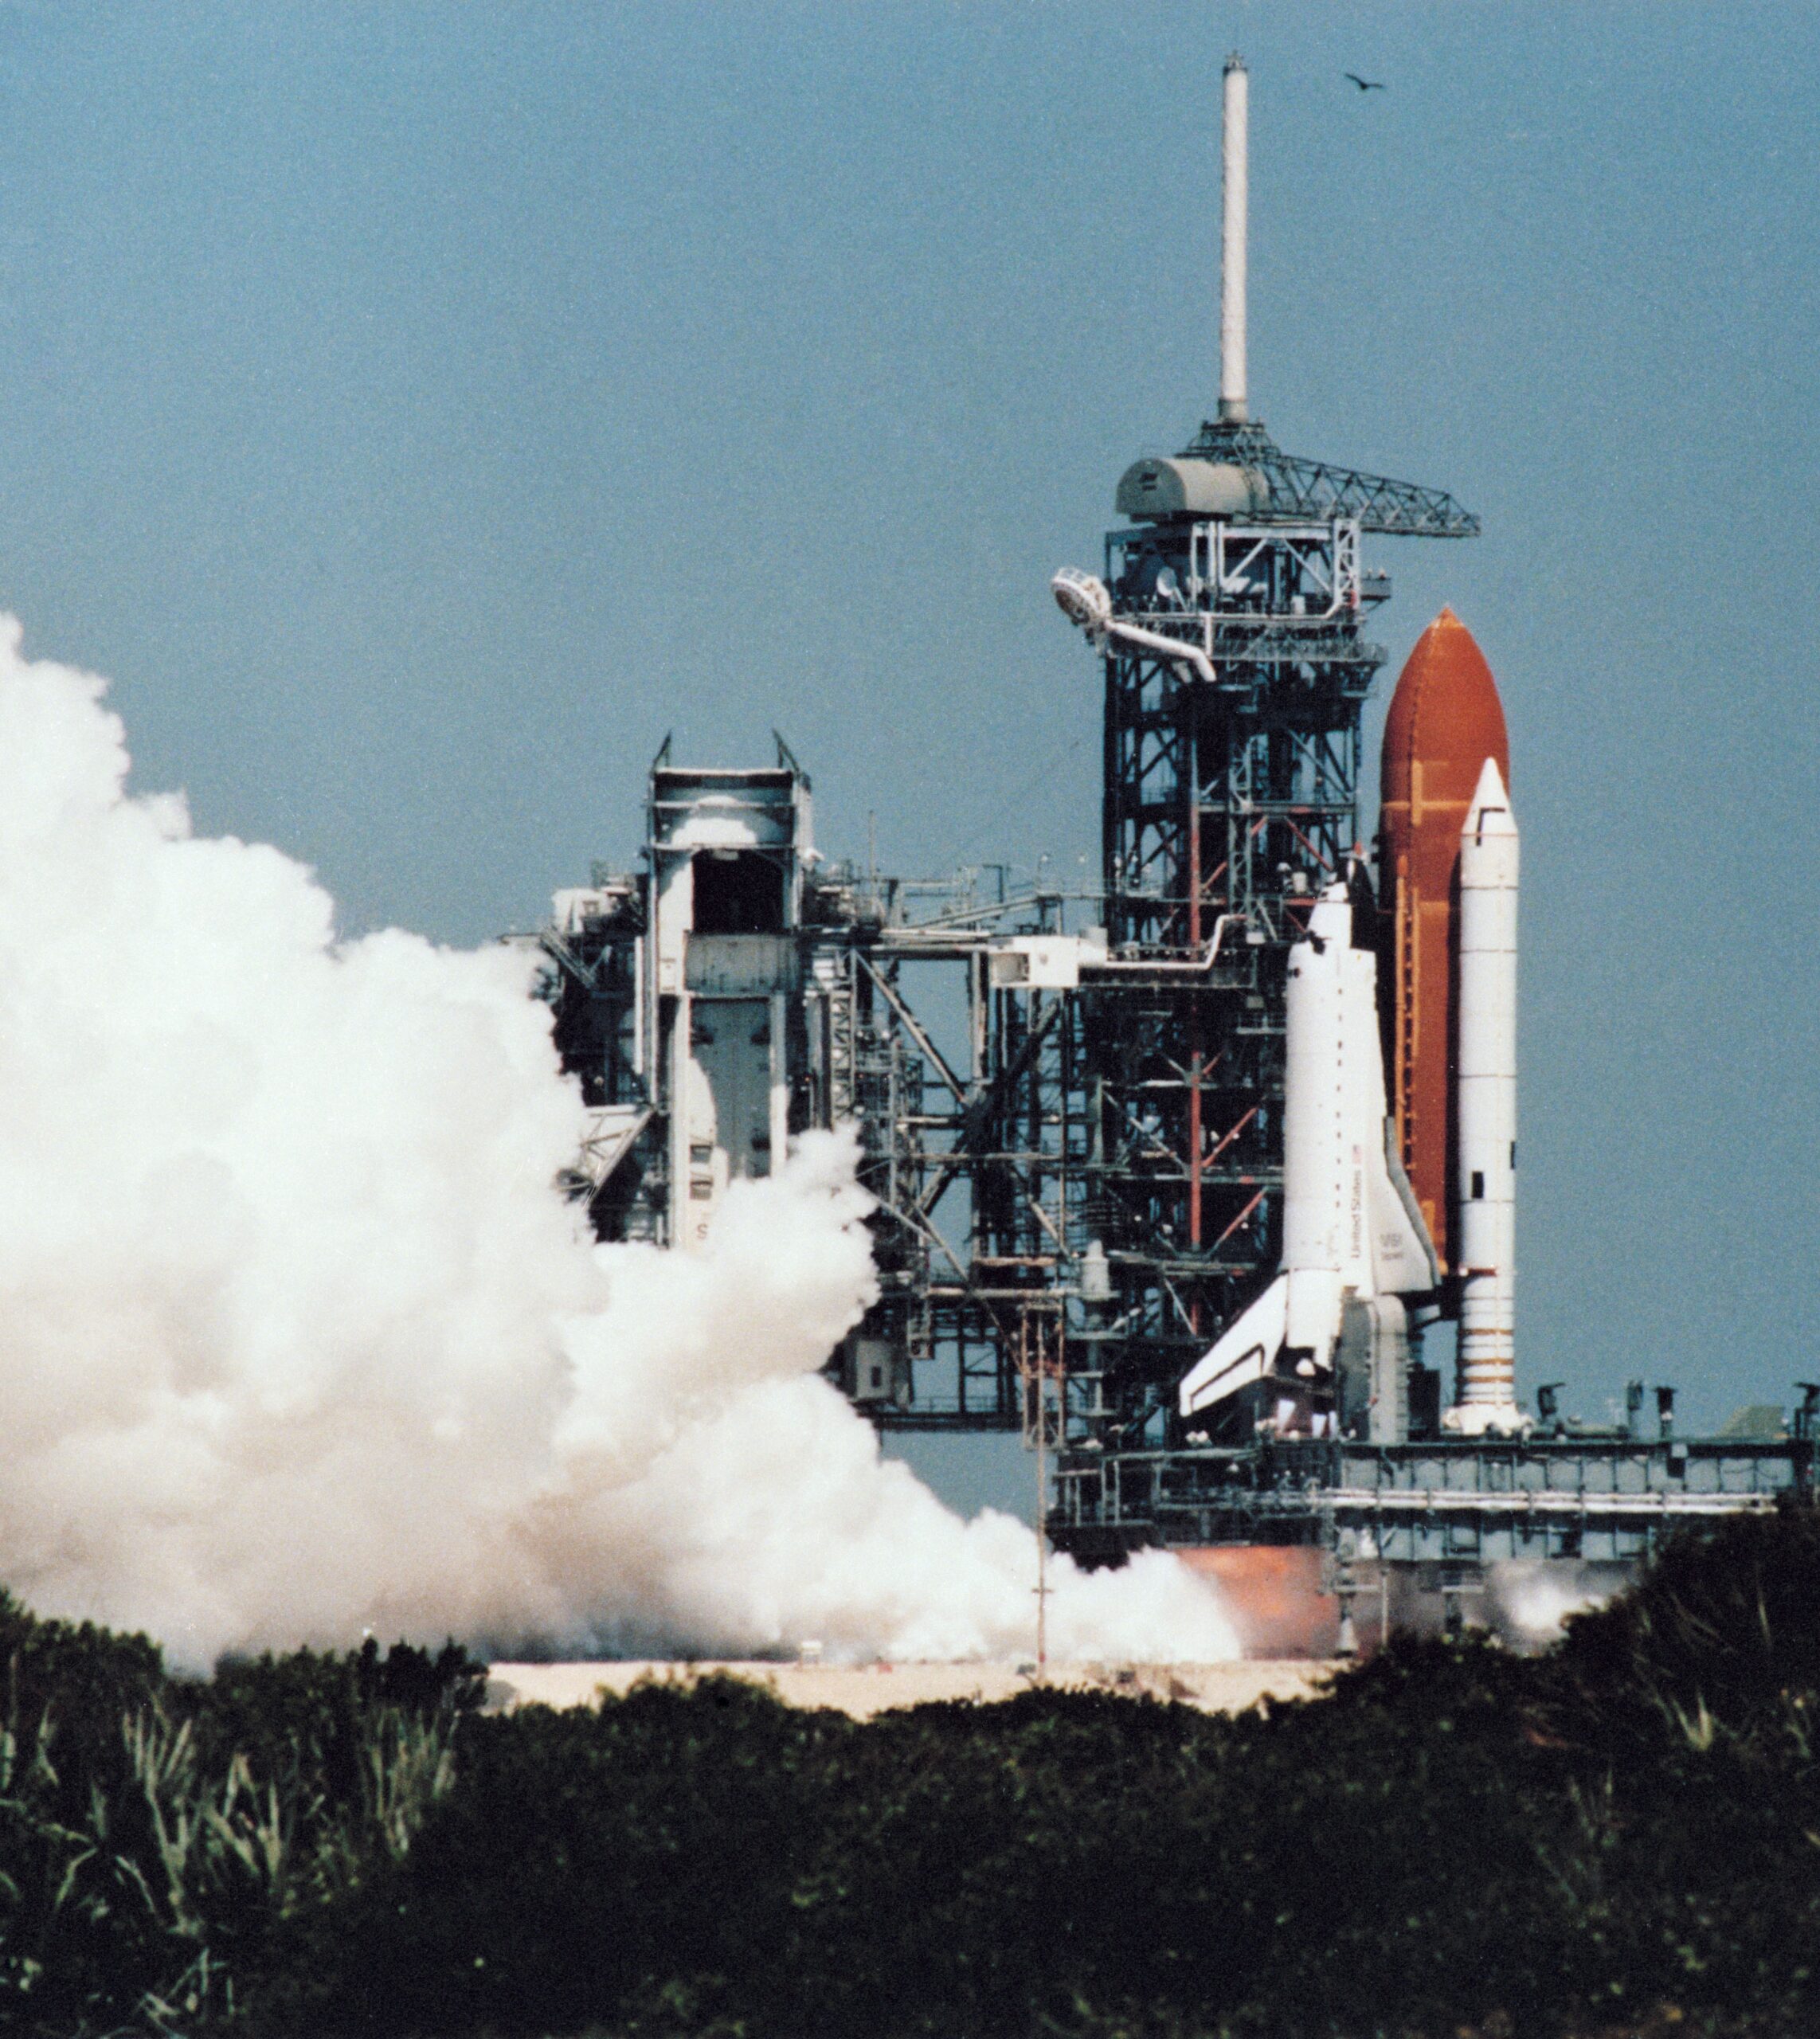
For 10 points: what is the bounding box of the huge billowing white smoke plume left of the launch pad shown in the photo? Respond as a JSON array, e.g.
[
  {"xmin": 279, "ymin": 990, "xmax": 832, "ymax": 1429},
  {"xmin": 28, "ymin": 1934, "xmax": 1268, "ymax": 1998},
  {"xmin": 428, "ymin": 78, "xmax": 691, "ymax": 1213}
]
[{"xmin": 0, "ymin": 618, "xmax": 1237, "ymax": 1666}]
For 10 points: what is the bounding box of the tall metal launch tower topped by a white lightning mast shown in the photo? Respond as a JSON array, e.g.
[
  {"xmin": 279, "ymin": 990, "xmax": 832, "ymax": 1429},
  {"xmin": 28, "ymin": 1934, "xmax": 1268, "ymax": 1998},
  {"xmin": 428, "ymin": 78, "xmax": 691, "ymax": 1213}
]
[{"xmin": 1055, "ymin": 57, "xmax": 1480, "ymax": 1482}]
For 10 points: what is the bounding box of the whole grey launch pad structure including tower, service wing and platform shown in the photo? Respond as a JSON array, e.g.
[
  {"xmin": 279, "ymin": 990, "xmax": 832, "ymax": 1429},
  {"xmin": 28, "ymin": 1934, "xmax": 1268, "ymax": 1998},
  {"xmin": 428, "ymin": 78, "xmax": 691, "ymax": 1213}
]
[{"xmin": 536, "ymin": 48, "xmax": 1816, "ymax": 1596}]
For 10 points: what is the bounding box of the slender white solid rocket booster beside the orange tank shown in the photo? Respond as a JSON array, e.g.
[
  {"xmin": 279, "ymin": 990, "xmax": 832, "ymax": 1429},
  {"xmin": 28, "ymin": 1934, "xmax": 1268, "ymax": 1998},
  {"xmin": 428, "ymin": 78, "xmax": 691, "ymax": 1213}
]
[{"xmin": 1443, "ymin": 758, "xmax": 1524, "ymax": 1435}]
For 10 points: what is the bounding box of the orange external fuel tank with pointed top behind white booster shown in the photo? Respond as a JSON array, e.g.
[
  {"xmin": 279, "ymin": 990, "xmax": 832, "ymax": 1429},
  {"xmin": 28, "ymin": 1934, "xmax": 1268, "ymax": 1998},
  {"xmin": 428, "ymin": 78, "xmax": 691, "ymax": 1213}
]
[{"xmin": 1378, "ymin": 609, "xmax": 1510, "ymax": 1274}]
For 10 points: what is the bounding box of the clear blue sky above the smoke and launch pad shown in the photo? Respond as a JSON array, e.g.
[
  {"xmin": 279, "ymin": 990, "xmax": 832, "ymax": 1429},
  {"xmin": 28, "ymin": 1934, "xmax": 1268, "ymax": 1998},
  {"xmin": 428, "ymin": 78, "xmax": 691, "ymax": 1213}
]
[{"xmin": 0, "ymin": 0, "xmax": 1820, "ymax": 1468}]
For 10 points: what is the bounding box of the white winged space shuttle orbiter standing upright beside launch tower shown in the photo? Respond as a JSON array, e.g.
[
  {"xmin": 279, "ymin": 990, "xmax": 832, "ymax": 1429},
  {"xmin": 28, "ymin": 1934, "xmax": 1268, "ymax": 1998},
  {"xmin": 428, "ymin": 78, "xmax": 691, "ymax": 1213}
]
[{"xmin": 1180, "ymin": 877, "xmax": 1439, "ymax": 1439}]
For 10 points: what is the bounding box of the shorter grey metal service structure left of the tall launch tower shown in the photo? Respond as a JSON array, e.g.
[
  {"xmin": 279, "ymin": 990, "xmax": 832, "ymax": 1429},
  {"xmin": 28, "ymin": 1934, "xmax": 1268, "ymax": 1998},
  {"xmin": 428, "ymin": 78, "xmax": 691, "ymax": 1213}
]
[{"xmin": 536, "ymin": 742, "xmax": 1106, "ymax": 1430}]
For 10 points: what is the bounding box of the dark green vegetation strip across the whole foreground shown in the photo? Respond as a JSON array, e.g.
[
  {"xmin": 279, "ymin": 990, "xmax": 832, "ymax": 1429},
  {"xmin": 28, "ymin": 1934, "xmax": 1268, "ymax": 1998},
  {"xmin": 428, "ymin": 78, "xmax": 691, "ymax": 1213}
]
[{"xmin": 0, "ymin": 1509, "xmax": 1820, "ymax": 2039}]
